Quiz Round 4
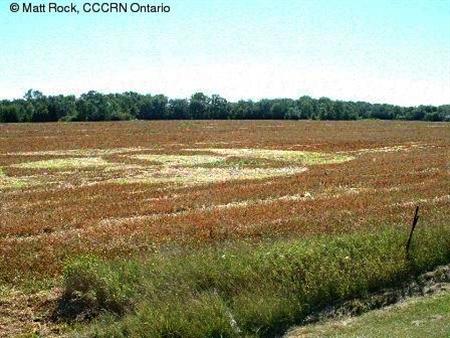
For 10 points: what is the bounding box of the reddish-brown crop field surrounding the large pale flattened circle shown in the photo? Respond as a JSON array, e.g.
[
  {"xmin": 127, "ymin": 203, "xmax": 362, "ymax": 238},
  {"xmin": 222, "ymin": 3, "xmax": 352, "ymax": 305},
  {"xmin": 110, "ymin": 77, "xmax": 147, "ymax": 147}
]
[{"xmin": 0, "ymin": 121, "xmax": 450, "ymax": 282}]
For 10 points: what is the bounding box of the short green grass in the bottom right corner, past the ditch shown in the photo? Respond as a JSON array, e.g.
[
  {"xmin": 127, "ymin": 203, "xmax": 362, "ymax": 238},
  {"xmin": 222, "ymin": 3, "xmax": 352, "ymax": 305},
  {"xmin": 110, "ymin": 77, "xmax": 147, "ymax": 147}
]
[{"xmin": 289, "ymin": 291, "xmax": 450, "ymax": 338}]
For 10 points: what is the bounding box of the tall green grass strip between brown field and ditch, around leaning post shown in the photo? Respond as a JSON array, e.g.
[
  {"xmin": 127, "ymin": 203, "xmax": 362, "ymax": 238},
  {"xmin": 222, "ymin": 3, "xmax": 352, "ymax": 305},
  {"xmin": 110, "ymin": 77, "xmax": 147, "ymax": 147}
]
[{"xmin": 61, "ymin": 225, "xmax": 450, "ymax": 337}]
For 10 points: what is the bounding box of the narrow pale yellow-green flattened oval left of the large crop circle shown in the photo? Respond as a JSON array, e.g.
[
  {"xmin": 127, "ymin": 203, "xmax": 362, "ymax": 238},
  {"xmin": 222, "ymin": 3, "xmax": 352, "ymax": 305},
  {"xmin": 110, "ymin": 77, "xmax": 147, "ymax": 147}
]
[{"xmin": 13, "ymin": 157, "xmax": 109, "ymax": 169}]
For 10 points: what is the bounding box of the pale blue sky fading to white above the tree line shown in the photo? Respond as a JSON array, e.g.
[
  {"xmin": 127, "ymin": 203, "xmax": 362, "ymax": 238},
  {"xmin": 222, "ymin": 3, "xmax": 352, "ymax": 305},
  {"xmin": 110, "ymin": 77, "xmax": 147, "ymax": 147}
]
[{"xmin": 0, "ymin": 0, "xmax": 450, "ymax": 105}]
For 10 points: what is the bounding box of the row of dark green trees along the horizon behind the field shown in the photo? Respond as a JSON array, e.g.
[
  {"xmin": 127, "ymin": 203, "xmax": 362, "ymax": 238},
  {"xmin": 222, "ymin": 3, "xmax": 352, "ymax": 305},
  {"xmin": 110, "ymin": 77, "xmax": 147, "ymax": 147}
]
[{"xmin": 0, "ymin": 89, "xmax": 450, "ymax": 123}]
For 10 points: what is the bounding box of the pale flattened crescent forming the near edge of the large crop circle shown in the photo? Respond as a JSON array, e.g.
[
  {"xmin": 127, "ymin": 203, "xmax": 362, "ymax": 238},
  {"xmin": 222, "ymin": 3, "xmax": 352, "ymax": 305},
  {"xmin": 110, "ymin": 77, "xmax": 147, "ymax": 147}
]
[{"xmin": 112, "ymin": 167, "xmax": 307, "ymax": 186}]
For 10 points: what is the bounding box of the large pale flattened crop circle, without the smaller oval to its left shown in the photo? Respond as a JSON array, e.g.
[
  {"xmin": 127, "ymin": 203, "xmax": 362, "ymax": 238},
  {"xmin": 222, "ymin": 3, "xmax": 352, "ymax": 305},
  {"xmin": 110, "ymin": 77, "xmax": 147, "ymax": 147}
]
[{"xmin": 112, "ymin": 148, "xmax": 353, "ymax": 186}]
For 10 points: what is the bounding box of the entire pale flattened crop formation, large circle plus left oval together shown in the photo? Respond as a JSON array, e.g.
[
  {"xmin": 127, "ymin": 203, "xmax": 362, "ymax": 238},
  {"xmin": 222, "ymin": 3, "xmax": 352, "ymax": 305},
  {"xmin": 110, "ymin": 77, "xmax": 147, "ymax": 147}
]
[{"xmin": 2, "ymin": 148, "xmax": 353, "ymax": 190}]
